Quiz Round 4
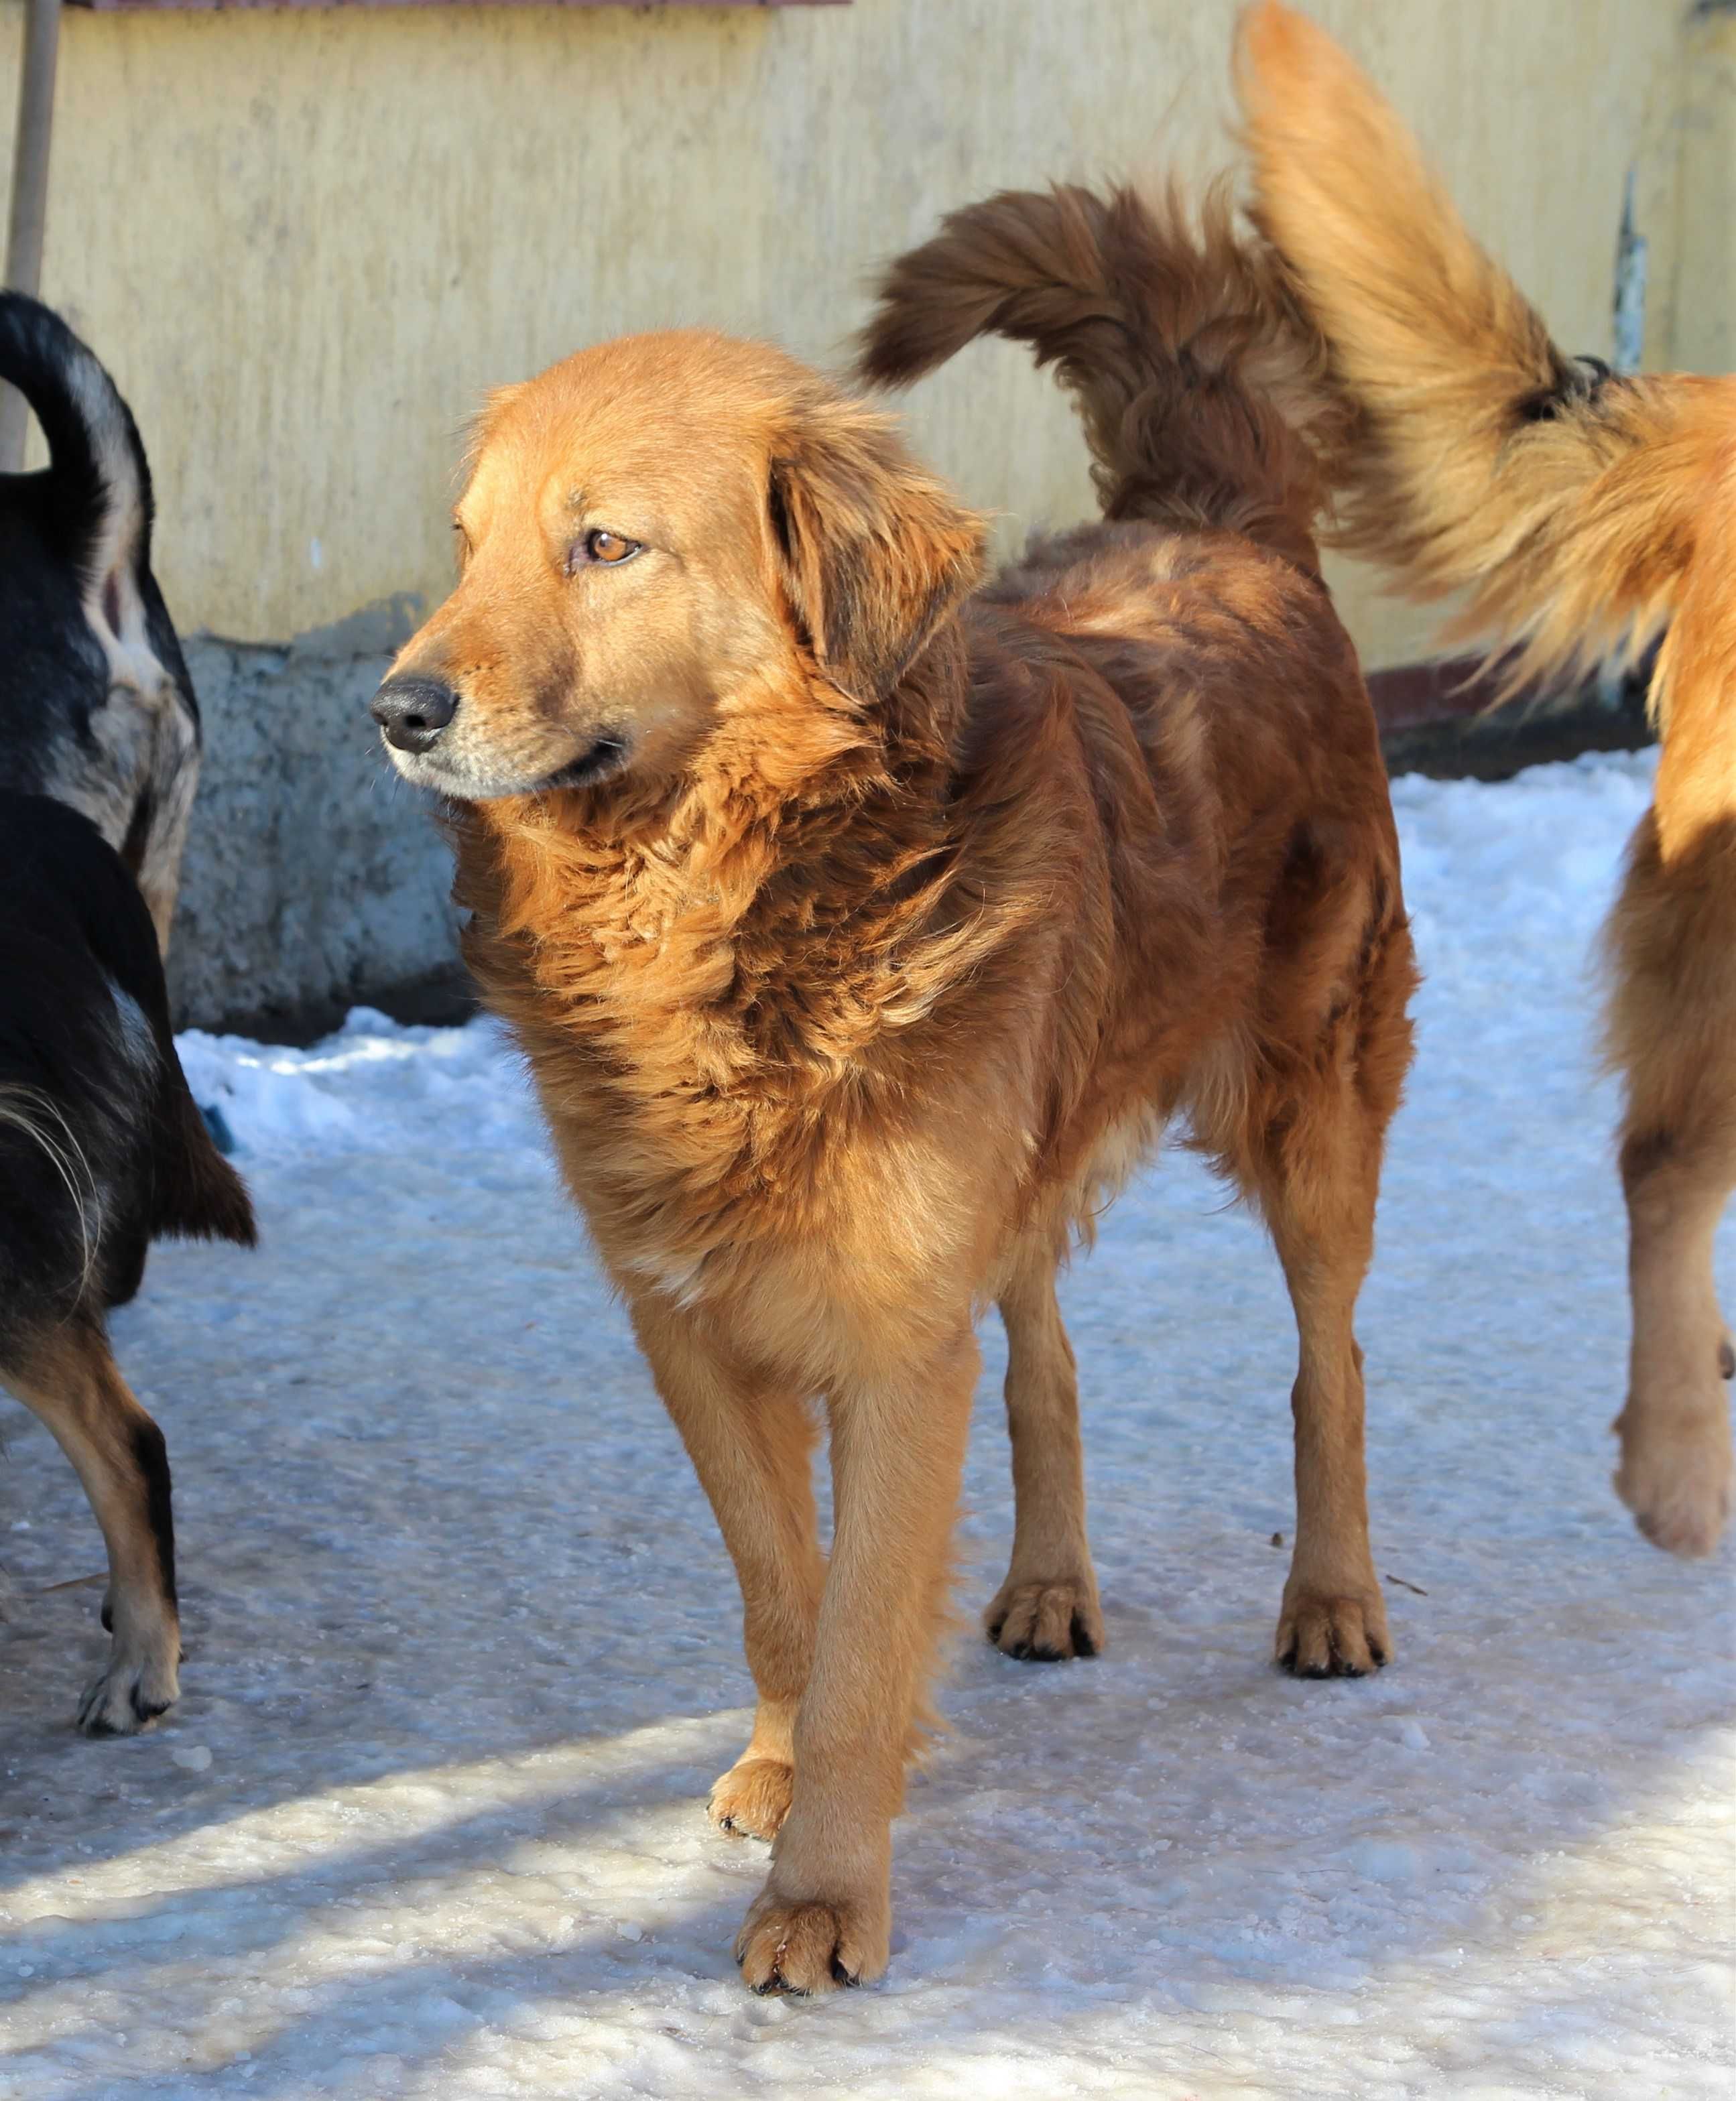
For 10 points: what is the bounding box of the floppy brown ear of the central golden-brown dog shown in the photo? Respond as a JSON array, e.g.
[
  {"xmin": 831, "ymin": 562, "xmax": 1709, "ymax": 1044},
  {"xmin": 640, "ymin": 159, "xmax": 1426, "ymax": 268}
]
[{"xmin": 767, "ymin": 399, "xmax": 983, "ymax": 702}]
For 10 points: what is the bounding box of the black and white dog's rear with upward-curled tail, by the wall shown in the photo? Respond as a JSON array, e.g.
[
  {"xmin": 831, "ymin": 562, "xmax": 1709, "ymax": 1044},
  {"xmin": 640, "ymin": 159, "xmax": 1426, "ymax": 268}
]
[{"xmin": 0, "ymin": 292, "xmax": 200, "ymax": 954}]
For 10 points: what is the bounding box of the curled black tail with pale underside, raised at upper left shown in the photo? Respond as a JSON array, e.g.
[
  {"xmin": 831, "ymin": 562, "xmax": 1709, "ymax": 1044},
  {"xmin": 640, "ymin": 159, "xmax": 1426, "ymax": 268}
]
[{"xmin": 0, "ymin": 292, "xmax": 151, "ymax": 584}]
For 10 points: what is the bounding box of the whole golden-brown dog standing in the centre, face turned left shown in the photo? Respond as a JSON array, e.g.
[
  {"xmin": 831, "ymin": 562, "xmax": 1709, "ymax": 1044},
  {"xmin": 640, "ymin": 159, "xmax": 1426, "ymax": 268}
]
[{"xmin": 376, "ymin": 191, "xmax": 1412, "ymax": 1992}]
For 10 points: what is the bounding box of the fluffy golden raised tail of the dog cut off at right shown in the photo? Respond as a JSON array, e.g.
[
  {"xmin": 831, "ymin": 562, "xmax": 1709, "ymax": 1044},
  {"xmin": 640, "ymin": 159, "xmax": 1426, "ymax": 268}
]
[{"xmin": 1236, "ymin": 0, "xmax": 1707, "ymax": 702}]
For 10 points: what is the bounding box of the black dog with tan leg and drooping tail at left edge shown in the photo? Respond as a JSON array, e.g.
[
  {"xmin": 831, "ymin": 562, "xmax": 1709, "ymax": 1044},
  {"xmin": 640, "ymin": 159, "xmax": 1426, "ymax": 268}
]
[{"xmin": 0, "ymin": 790, "xmax": 254, "ymax": 1736}]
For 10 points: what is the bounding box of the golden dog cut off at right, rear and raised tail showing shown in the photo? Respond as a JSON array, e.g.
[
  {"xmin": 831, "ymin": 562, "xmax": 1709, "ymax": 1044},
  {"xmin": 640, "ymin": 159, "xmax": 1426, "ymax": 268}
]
[{"xmin": 1240, "ymin": 0, "xmax": 1736, "ymax": 1555}]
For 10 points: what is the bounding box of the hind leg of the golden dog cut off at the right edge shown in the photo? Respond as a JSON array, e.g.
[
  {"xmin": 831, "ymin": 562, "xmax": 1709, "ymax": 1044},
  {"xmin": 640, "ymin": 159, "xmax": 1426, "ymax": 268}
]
[{"xmin": 1610, "ymin": 802, "xmax": 1736, "ymax": 1555}]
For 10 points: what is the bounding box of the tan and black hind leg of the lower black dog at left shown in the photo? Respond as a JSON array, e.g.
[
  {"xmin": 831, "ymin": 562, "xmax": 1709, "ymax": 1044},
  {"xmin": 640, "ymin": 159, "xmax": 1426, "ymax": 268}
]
[{"xmin": 6, "ymin": 1316, "xmax": 181, "ymax": 1736}]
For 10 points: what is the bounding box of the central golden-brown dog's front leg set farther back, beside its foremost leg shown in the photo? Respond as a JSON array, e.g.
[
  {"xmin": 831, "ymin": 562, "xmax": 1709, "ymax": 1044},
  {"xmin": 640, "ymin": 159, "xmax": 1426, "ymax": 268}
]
[{"xmin": 633, "ymin": 1303, "xmax": 826, "ymax": 1838}]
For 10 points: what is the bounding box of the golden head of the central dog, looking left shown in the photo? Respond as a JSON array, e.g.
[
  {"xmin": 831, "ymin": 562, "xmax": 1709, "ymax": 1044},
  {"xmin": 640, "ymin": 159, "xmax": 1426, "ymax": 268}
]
[{"xmin": 372, "ymin": 332, "xmax": 981, "ymax": 803}]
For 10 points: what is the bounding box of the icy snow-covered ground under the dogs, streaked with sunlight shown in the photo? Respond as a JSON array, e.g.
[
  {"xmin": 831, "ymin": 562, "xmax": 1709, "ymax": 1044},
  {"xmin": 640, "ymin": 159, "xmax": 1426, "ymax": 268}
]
[{"xmin": 0, "ymin": 759, "xmax": 1736, "ymax": 2101}]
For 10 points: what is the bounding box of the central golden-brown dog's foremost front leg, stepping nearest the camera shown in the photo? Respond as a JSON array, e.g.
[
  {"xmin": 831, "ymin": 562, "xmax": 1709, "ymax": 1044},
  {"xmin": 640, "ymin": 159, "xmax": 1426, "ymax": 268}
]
[{"xmin": 735, "ymin": 1324, "xmax": 977, "ymax": 1992}]
